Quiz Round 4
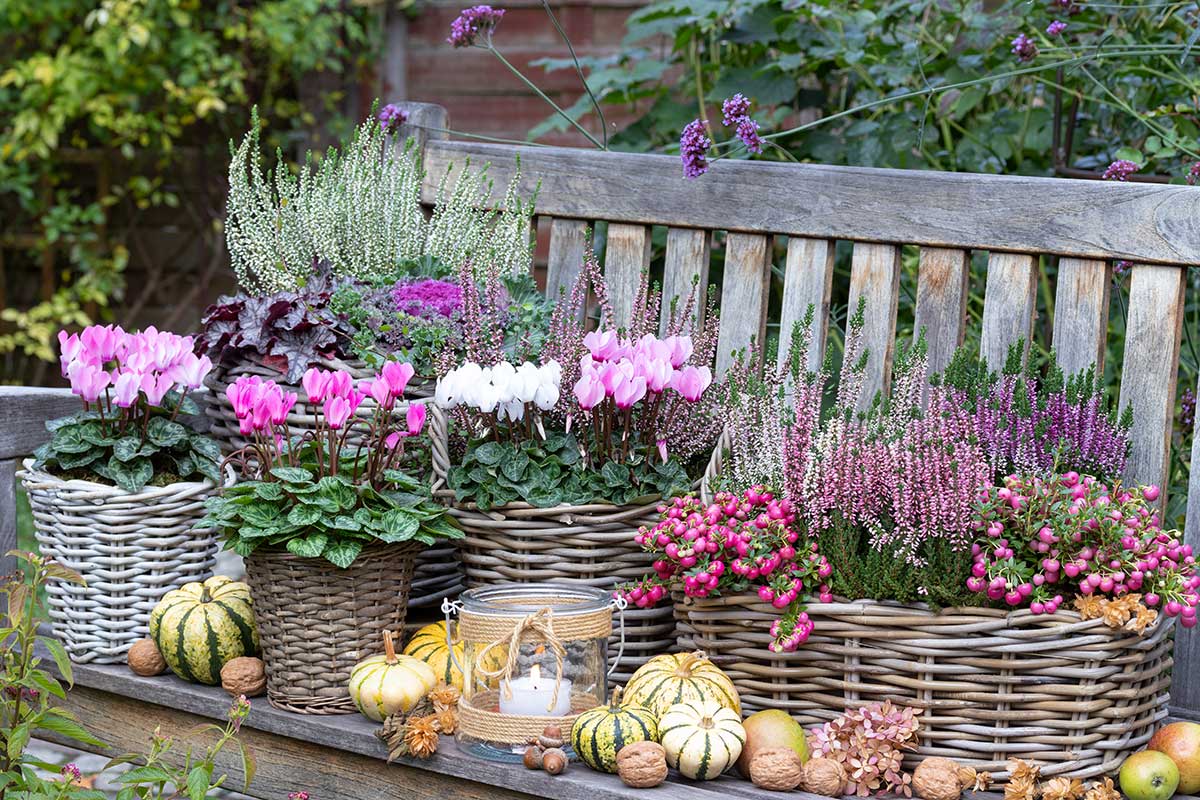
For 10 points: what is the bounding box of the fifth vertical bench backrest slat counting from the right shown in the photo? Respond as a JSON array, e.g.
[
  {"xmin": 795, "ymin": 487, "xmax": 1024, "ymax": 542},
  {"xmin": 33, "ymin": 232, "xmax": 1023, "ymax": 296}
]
[{"xmin": 844, "ymin": 242, "xmax": 900, "ymax": 410}]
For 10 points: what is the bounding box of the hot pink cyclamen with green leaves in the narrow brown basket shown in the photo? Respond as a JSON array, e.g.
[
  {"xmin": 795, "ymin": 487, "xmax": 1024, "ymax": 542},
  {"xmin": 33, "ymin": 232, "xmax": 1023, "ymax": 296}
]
[{"xmin": 202, "ymin": 362, "xmax": 462, "ymax": 569}]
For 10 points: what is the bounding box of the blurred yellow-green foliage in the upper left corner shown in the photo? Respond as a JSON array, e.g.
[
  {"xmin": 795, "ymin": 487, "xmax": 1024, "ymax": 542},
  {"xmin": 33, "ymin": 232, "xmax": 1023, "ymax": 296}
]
[{"xmin": 0, "ymin": 0, "xmax": 377, "ymax": 377}]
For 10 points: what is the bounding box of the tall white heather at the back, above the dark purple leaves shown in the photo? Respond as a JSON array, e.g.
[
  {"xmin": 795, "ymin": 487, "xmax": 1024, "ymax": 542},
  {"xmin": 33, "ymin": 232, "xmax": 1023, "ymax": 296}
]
[{"xmin": 226, "ymin": 105, "xmax": 534, "ymax": 295}]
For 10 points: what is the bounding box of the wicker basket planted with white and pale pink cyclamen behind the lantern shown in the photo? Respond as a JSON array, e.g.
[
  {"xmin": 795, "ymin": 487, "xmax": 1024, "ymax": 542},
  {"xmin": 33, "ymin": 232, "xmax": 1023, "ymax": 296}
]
[{"xmin": 434, "ymin": 245, "xmax": 719, "ymax": 680}]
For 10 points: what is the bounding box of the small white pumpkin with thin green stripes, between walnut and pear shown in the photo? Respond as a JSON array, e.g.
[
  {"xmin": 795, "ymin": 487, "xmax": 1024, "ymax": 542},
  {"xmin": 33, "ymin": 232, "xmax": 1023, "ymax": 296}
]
[{"xmin": 659, "ymin": 700, "xmax": 746, "ymax": 781}]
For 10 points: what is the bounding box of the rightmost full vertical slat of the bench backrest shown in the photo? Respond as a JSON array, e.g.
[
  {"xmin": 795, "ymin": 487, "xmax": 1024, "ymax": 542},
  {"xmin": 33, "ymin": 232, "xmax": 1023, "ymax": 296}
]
[{"xmin": 1121, "ymin": 264, "xmax": 1186, "ymax": 503}]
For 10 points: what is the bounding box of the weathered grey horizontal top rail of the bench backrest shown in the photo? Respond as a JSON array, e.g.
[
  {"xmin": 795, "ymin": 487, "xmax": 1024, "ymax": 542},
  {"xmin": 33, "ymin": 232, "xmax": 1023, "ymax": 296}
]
[{"xmin": 422, "ymin": 142, "xmax": 1200, "ymax": 264}]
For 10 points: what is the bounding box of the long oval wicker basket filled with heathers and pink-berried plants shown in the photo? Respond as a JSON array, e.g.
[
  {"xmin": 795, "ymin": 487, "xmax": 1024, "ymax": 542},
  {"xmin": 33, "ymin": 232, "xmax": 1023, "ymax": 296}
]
[{"xmin": 630, "ymin": 303, "xmax": 1200, "ymax": 780}]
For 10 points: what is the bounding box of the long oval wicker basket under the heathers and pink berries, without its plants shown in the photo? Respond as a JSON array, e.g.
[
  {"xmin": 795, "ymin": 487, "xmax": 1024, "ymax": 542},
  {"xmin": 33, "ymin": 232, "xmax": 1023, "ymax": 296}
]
[{"xmin": 676, "ymin": 595, "xmax": 1172, "ymax": 781}]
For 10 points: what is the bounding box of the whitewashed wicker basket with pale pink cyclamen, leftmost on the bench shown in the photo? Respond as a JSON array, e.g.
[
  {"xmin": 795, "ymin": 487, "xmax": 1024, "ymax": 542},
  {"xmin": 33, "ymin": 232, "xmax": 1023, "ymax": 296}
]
[{"xmin": 20, "ymin": 325, "xmax": 221, "ymax": 663}]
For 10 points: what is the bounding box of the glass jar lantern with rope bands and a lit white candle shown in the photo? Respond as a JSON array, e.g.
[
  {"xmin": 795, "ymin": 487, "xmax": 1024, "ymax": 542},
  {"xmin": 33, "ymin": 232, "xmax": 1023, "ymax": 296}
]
[{"xmin": 442, "ymin": 583, "xmax": 625, "ymax": 762}]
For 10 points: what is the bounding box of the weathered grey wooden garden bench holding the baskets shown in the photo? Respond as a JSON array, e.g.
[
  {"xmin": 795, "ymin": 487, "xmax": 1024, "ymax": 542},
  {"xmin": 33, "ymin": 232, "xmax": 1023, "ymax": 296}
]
[{"xmin": 0, "ymin": 104, "xmax": 1200, "ymax": 800}]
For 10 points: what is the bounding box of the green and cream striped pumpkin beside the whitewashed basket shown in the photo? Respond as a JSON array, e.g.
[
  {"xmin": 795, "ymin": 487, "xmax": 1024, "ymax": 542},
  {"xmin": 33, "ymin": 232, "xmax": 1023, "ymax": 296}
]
[{"xmin": 150, "ymin": 575, "xmax": 258, "ymax": 686}]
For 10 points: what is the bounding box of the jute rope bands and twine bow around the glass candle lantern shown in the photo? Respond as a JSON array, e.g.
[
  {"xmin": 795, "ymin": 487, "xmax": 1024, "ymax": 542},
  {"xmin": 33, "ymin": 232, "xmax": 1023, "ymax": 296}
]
[{"xmin": 458, "ymin": 597, "xmax": 612, "ymax": 745}]
